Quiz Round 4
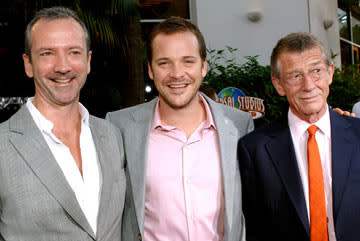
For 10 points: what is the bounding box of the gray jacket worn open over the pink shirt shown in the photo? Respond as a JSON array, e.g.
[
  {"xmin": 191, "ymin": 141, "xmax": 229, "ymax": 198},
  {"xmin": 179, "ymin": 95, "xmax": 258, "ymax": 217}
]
[{"xmin": 106, "ymin": 96, "xmax": 254, "ymax": 241}]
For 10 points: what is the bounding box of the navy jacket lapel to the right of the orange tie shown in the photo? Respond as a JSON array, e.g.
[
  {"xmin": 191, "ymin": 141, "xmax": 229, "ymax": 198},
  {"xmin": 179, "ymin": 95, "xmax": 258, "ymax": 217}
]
[{"xmin": 330, "ymin": 110, "xmax": 357, "ymax": 220}]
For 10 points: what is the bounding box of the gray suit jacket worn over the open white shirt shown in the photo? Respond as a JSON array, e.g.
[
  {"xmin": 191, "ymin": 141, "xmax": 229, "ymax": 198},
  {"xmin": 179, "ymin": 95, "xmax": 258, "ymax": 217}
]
[{"xmin": 0, "ymin": 106, "xmax": 126, "ymax": 241}]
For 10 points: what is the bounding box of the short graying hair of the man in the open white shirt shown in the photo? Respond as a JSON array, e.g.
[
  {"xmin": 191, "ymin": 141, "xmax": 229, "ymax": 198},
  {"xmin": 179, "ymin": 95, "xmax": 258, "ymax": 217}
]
[{"xmin": 25, "ymin": 7, "xmax": 90, "ymax": 62}]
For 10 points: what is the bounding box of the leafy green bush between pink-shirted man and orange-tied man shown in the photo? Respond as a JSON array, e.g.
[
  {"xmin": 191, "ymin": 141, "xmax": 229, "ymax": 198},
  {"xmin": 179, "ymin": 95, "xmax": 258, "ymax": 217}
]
[{"xmin": 204, "ymin": 46, "xmax": 288, "ymax": 126}]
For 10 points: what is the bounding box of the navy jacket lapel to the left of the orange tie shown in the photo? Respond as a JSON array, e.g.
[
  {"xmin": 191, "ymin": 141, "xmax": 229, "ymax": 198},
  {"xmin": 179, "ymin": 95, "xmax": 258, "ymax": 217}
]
[{"xmin": 266, "ymin": 118, "xmax": 310, "ymax": 234}]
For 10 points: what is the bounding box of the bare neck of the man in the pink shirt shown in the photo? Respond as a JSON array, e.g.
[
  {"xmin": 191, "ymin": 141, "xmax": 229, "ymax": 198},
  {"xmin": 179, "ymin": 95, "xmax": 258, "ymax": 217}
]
[{"xmin": 159, "ymin": 96, "xmax": 206, "ymax": 137}]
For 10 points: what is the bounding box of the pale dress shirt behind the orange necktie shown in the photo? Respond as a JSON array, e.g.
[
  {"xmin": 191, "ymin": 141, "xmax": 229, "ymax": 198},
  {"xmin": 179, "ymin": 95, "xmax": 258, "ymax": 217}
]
[{"xmin": 288, "ymin": 108, "xmax": 336, "ymax": 241}]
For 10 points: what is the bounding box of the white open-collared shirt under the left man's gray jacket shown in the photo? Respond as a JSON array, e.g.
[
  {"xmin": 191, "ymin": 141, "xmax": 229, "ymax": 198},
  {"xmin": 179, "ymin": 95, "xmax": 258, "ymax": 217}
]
[{"xmin": 26, "ymin": 98, "xmax": 102, "ymax": 234}]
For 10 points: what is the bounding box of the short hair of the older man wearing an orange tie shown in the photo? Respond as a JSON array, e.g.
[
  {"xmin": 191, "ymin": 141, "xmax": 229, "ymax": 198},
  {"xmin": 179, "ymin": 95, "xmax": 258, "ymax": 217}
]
[{"xmin": 270, "ymin": 32, "xmax": 332, "ymax": 78}]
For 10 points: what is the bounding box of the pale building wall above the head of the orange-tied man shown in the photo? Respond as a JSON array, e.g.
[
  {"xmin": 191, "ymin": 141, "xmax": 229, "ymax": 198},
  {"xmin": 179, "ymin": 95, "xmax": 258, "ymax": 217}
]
[{"xmin": 192, "ymin": 0, "xmax": 340, "ymax": 65}]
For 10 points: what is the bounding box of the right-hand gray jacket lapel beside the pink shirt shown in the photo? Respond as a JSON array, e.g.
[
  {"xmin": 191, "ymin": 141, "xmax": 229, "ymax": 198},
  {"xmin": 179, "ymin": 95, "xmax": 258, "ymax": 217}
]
[{"xmin": 205, "ymin": 96, "xmax": 240, "ymax": 230}]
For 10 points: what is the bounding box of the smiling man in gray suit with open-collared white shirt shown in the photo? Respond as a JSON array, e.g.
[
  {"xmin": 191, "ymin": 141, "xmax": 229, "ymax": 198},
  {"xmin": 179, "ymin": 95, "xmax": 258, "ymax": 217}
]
[{"xmin": 0, "ymin": 7, "xmax": 126, "ymax": 241}]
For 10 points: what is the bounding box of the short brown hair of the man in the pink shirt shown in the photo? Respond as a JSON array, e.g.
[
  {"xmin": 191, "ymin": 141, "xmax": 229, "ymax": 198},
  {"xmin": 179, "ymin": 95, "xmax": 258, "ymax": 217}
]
[{"xmin": 147, "ymin": 17, "xmax": 206, "ymax": 64}]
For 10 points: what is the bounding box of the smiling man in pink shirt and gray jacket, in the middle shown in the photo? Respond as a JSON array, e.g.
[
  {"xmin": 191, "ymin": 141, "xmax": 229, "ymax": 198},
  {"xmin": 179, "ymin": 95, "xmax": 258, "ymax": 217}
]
[{"xmin": 107, "ymin": 17, "xmax": 253, "ymax": 241}]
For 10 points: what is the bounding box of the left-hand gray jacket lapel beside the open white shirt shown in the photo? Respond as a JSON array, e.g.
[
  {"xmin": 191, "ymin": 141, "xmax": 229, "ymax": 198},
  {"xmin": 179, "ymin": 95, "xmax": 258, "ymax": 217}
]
[{"xmin": 10, "ymin": 106, "xmax": 95, "ymax": 239}]
